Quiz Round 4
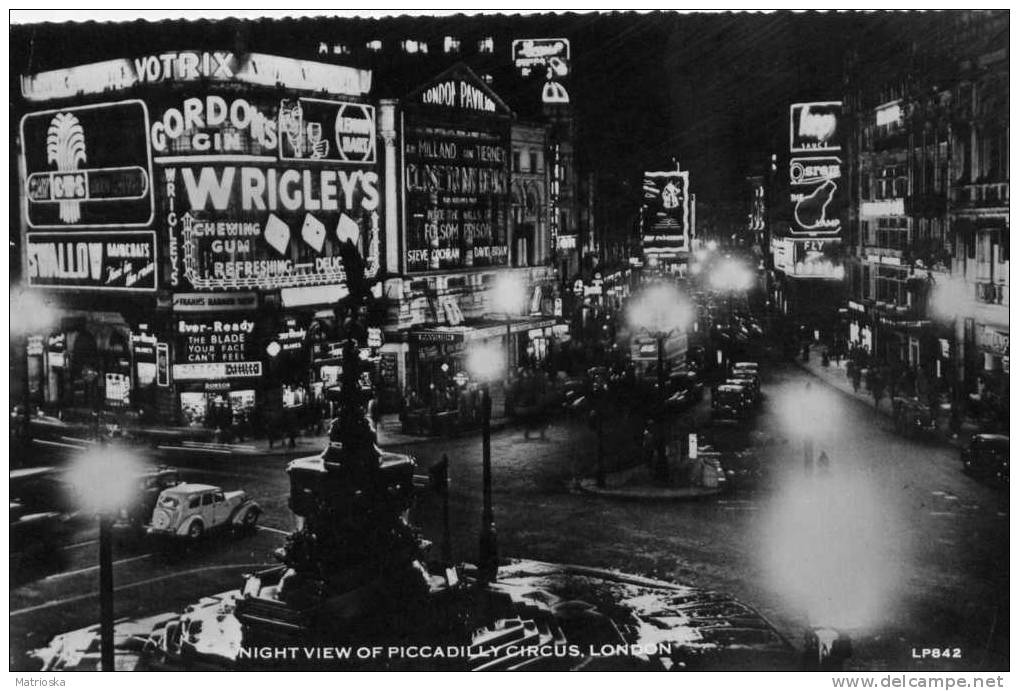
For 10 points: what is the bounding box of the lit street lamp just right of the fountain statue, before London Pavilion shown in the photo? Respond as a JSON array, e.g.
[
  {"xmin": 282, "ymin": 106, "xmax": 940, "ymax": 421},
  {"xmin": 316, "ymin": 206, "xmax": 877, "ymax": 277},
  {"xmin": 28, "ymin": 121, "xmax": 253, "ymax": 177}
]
[{"xmin": 467, "ymin": 344, "xmax": 505, "ymax": 583}]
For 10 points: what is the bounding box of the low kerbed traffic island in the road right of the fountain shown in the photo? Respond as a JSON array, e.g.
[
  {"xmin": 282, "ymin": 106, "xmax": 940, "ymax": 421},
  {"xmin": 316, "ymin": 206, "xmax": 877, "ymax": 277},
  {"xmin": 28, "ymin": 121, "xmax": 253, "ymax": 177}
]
[{"xmin": 575, "ymin": 462, "xmax": 726, "ymax": 501}]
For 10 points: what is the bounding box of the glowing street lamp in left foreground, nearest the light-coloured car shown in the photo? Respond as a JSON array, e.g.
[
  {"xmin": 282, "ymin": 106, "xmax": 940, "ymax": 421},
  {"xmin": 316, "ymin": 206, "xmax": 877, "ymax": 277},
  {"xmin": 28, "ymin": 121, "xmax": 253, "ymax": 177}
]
[{"xmin": 68, "ymin": 444, "xmax": 138, "ymax": 672}]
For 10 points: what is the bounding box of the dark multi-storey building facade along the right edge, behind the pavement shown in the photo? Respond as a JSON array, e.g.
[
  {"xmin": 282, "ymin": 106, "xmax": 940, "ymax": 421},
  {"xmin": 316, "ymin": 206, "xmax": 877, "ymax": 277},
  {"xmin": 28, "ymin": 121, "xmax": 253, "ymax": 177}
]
[{"xmin": 843, "ymin": 12, "xmax": 1009, "ymax": 421}]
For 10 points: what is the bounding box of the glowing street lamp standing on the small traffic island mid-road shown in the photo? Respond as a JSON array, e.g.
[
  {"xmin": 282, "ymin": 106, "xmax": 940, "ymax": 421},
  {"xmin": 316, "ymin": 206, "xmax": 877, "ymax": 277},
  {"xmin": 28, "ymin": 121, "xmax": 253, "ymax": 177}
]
[{"xmin": 629, "ymin": 283, "xmax": 692, "ymax": 482}]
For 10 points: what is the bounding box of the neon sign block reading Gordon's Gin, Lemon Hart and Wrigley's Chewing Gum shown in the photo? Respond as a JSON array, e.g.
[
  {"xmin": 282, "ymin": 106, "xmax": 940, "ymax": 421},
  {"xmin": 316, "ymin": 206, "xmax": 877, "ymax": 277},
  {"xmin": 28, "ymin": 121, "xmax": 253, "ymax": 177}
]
[{"xmin": 152, "ymin": 94, "xmax": 381, "ymax": 290}]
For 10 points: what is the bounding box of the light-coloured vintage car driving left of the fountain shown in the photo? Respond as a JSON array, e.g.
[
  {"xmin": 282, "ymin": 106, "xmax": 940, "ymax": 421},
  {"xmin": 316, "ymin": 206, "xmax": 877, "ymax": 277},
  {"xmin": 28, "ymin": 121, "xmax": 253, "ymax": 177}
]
[{"xmin": 148, "ymin": 482, "xmax": 262, "ymax": 540}]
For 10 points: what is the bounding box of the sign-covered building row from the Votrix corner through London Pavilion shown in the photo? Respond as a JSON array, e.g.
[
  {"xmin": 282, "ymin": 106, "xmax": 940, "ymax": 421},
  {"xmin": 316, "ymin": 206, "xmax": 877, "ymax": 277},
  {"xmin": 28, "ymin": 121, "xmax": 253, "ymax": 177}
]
[{"xmin": 16, "ymin": 50, "xmax": 555, "ymax": 427}]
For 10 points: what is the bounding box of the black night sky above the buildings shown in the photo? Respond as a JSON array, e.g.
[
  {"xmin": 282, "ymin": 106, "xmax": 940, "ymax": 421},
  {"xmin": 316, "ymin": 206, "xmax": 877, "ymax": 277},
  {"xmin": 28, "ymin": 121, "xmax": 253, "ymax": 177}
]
[{"xmin": 10, "ymin": 11, "xmax": 961, "ymax": 235}]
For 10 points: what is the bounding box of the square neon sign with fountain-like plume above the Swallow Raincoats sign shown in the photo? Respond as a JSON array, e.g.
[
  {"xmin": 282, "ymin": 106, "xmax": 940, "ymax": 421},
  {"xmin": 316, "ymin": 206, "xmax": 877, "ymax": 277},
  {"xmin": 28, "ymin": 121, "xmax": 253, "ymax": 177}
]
[{"xmin": 20, "ymin": 100, "xmax": 153, "ymax": 230}]
